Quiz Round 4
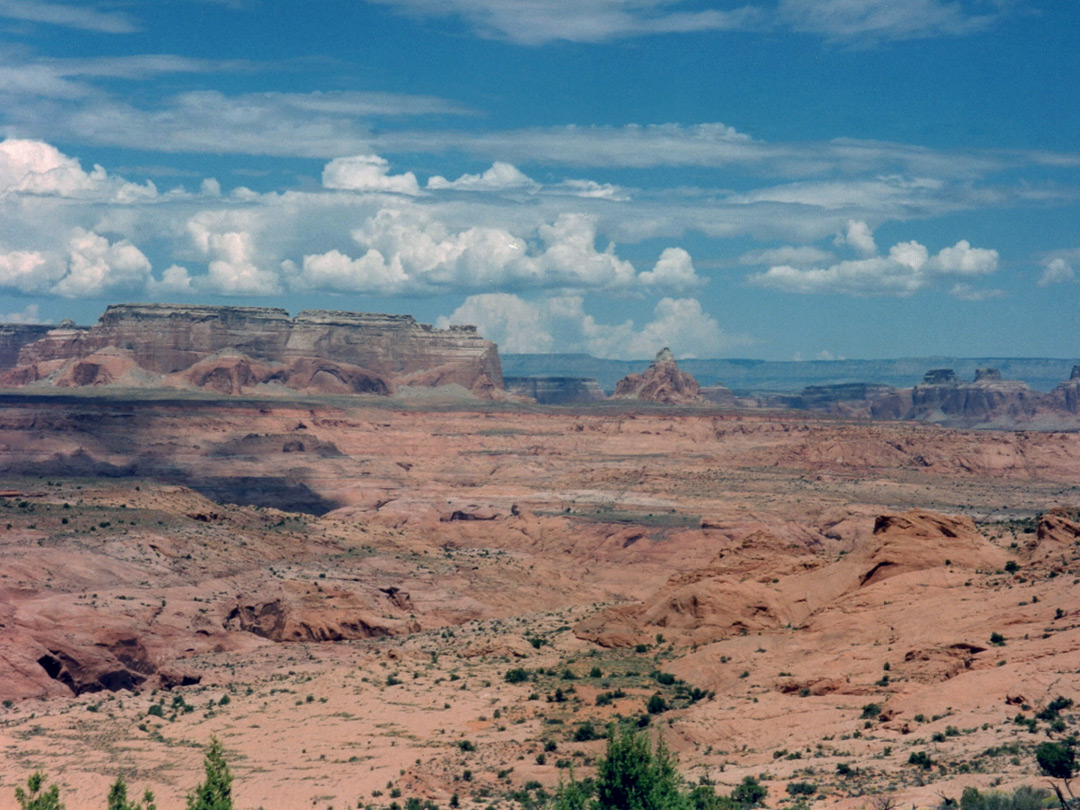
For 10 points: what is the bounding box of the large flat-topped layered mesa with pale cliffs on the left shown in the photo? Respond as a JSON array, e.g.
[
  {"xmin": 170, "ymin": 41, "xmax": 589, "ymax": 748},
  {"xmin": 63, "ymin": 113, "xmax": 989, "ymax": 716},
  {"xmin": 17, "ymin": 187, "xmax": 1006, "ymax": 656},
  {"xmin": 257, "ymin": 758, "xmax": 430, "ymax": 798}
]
[{"xmin": 0, "ymin": 303, "xmax": 502, "ymax": 396}]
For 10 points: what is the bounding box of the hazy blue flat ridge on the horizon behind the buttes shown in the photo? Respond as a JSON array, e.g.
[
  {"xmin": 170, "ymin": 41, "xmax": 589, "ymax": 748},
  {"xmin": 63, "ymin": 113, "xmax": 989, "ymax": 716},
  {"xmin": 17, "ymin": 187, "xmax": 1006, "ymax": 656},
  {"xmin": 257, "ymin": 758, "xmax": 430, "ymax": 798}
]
[{"xmin": 500, "ymin": 352, "xmax": 1080, "ymax": 394}]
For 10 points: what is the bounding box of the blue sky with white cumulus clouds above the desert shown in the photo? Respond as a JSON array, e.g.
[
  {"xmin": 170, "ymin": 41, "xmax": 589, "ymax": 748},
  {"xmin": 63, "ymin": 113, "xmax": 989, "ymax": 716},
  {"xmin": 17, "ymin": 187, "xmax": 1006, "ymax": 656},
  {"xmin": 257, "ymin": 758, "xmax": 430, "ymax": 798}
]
[{"xmin": 0, "ymin": 0, "xmax": 1080, "ymax": 360}]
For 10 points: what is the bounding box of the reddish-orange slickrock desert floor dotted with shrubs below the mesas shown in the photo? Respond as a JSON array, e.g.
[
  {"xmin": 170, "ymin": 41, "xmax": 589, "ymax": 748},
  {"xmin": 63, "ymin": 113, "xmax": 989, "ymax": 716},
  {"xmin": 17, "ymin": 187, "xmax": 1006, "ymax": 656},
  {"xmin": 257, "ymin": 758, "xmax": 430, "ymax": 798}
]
[{"xmin": 0, "ymin": 388, "xmax": 1080, "ymax": 810}]
